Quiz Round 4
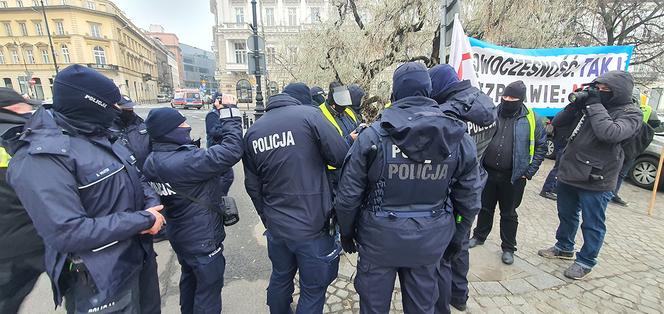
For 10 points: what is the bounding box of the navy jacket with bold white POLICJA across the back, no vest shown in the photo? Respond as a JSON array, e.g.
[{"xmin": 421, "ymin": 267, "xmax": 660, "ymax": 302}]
[{"xmin": 243, "ymin": 94, "xmax": 348, "ymax": 240}]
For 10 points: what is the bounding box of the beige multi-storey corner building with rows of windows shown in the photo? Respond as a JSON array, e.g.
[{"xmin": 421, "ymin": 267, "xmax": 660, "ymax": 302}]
[{"xmin": 0, "ymin": 0, "xmax": 159, "ymax": 102}]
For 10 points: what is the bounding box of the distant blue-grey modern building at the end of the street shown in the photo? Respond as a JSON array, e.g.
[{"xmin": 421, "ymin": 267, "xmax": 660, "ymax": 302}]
[{"xmin": 180, "ymin": 44, "xmax": 218, "ymax": 92}]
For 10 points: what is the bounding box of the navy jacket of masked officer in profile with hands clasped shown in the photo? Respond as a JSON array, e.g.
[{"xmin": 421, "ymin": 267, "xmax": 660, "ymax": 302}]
[{"xmin": 4, "ymin": 108, "xmax": 160, "ymax": 304}]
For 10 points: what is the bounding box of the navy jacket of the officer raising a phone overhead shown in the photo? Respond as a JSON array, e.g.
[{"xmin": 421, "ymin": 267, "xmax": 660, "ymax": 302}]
[{"xmin": 143, "ymin": 109, "xmax": 242, "ymax": 256}]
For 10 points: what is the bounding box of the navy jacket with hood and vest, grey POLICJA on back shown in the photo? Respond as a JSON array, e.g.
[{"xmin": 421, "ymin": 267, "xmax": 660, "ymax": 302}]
[{"xmin": 334, "ymin": 96, "xmax": 483, "ymax": 267}]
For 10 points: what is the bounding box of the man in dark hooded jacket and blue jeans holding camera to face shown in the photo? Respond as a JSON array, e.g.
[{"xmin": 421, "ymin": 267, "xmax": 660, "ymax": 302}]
[{"xmin": 538, "ymin": 71, "xmax": 642, "ymax": 279}]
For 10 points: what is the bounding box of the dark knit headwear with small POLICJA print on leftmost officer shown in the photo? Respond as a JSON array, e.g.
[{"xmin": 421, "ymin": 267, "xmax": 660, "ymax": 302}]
[{"xmin": 52, "ymin": 64, "xmax": 122, "ymax": 127}]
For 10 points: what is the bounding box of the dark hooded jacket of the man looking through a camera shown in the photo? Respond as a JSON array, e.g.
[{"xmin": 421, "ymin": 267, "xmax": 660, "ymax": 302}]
[{"xmin": 553, "ymin": 71, "xmax": 643, "ymax": 192}]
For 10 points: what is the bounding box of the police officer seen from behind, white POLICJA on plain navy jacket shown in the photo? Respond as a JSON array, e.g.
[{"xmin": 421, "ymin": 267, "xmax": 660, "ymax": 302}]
[{"xmin": 243, "ymin": 94, "xmax": 348, "ymax": 314}]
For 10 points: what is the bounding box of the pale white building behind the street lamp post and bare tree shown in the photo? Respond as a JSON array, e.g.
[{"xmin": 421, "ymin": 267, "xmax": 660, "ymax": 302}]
[{"xmin": 210, "ymin": 0, "xmax": 330, "ymax": 110}]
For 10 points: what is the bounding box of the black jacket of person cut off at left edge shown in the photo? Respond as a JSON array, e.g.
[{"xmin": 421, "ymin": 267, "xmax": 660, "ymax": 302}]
[{"xmin": 0, "ymin": 109, "xmax": 44, "ymax": 261}]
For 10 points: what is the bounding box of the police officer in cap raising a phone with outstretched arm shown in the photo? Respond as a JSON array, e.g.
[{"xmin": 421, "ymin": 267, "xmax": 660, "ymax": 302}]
[{"xmin": 143, "ymin": 106, "xmax": 242, "ymax": 314}]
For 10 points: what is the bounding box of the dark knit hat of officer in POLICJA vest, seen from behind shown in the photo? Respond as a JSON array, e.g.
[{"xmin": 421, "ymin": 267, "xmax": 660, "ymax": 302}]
[{"xmin": 392, "ymin": 62, "xmax": 431, "ymax": 101}]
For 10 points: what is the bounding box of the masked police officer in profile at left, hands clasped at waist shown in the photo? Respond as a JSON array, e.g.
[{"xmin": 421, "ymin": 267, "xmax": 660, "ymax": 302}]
[{"xmin": 8, "ymin": 65, "xmax": 164, "ymax": 313}]
